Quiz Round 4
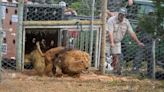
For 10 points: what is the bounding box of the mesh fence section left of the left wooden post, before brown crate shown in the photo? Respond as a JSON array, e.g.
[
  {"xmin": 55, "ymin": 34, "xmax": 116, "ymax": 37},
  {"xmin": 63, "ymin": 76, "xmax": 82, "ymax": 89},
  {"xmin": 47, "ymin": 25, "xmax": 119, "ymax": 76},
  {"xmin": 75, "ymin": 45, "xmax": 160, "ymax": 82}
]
[{"xmin": 0, "ymin": 3, "xmax": 18, "ymax": 77}]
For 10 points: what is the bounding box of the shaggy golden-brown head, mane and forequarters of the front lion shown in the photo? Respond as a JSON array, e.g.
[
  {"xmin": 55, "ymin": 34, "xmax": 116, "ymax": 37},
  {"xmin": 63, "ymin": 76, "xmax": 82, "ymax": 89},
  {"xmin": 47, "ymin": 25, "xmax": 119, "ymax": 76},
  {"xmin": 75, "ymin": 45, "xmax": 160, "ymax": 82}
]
[{"xmin": 55, "ymin": 50, "xmax": 90, "ymax": 77}]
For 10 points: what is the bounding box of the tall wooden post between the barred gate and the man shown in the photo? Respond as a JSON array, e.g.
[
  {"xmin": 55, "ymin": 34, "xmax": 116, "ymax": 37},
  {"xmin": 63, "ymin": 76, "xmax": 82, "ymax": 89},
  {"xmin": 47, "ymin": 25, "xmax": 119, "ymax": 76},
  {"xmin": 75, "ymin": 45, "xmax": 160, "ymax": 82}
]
[{"xmin": 100, "ymin": 0, "xmax": 107, "ymax": 74}]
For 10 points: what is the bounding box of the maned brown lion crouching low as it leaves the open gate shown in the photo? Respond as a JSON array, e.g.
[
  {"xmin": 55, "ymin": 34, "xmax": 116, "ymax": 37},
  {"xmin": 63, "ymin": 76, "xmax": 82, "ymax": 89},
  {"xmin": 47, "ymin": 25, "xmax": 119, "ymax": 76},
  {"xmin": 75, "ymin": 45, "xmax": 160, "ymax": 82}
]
[{"xmin": 37, "ymin": 43, "xmax": 90, "ymax": 76}]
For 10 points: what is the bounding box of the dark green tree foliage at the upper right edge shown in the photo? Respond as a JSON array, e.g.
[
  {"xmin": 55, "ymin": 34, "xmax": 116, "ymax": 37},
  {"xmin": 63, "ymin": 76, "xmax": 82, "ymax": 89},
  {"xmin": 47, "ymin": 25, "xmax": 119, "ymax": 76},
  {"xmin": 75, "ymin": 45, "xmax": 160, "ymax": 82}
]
[{"xmin": 139, "ymin": 0, "xmax": 164, "ymax": 38}]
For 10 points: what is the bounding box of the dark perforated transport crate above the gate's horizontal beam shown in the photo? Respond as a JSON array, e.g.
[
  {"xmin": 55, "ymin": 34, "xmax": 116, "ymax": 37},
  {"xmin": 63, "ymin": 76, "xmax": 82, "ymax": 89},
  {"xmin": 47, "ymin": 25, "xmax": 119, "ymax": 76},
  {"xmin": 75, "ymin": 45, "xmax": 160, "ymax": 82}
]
[{"xmin": 24, "ymin": 4, "xmax": 64, "ymax": 21}]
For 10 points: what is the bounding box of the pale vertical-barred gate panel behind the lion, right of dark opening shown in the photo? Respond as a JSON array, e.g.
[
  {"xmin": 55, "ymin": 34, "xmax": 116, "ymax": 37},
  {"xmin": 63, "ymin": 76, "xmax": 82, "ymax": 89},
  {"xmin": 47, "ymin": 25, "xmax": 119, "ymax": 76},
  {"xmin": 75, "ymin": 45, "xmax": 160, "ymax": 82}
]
[{"xmin": 60, "ymin": 25, "xmax": 100, "ymax": 68}]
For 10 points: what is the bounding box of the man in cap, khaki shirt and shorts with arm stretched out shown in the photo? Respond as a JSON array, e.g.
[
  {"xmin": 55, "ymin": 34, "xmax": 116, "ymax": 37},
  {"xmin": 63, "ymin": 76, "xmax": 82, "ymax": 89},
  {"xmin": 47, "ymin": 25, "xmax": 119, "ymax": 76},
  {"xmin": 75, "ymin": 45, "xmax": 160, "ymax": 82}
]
[{"xmin": 107, "ymin": 8, "xmax": 144, "ymax": 75}]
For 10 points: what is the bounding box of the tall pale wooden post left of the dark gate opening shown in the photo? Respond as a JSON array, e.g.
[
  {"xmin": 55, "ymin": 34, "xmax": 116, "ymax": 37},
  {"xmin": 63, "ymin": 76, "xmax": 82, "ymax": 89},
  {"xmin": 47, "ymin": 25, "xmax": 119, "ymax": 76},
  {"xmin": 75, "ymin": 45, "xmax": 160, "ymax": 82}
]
[{"xmin": 16, "ymin": 0, "xmax": 24, "ymax": 71}]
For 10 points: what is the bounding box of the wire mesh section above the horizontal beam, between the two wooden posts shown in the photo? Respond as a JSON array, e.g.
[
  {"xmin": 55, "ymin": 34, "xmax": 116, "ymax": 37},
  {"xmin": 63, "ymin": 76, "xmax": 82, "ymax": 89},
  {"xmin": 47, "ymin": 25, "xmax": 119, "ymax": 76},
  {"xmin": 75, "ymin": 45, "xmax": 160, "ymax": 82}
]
[{"xmin": 24, "ymin": 0, "xmax": 100, "ymax": 20}]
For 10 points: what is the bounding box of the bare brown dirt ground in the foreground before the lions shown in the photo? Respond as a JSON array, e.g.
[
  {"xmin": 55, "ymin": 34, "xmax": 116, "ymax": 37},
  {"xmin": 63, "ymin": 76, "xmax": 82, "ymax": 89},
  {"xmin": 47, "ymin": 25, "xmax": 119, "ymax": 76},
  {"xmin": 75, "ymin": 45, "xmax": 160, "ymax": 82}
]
[{"xmin": 0, "ymin": 70, "xmax": 164, "ymax": 92}]
